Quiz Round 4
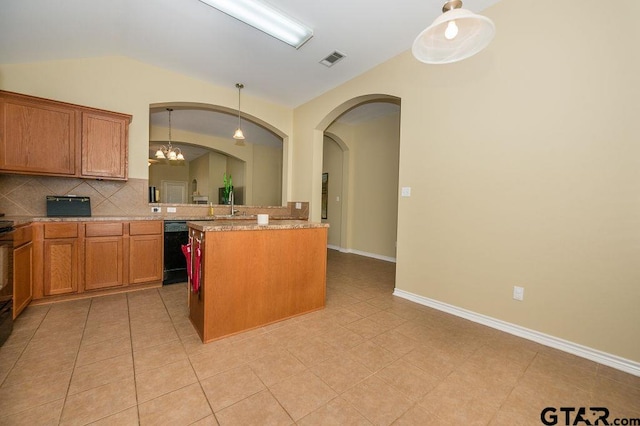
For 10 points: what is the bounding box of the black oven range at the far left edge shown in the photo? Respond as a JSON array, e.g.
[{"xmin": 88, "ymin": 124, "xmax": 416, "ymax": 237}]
[{"xmin": 0, "ymin": 220, "xmax": 14, "ymax": 346}]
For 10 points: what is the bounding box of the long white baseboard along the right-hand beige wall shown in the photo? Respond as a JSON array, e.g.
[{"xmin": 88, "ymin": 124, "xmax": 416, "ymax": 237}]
[{"xmin": 393, "ymin": 289, "xmax": 640, "ymax": 377}]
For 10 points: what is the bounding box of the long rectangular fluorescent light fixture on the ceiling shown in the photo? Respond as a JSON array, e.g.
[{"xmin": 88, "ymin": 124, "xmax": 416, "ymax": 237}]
[{"xmin": 200, "ymin": 0, "xmax": 313, "ymax": 49}]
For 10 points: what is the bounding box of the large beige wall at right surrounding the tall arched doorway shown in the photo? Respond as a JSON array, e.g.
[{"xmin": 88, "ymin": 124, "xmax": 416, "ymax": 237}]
[{"xmin": 293, "ymin": 0, "xmax": 640, "ymax": 361}]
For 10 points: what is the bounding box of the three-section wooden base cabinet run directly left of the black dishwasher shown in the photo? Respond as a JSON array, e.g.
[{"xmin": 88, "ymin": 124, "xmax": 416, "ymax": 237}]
[{"xmin": 32, "ymin": 220, "xmax": 164, "ymax": 300}]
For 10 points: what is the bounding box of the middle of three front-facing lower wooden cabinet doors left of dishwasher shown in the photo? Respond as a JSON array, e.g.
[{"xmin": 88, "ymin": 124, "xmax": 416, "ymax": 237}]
[{"xmin": 84, "ymin": 236, "xmax": 125, "ymax": 290}]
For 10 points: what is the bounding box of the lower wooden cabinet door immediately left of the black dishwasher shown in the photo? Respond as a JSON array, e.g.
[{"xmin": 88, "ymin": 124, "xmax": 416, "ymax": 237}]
[{"xmin": 129, "ymin": 235, "xmax": 163, "ymax": 284}]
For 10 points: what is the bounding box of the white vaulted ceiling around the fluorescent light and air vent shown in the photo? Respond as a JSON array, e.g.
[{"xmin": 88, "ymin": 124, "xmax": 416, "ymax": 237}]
[{"xmin": 0, "ymin": 0, "xmax": 499, "ymax": 107}]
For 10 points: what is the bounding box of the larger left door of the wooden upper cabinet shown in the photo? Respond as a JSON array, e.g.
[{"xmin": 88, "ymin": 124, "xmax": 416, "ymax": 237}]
[{"xmin": 0, "ymin": 95, "xmax": 78, "ymax": 175}]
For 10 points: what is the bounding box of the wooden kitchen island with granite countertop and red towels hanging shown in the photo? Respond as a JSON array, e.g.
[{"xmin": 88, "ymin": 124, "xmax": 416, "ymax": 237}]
[{"xmin": 187, "ymin": 220, "xmax": 328, "ymax": 343}]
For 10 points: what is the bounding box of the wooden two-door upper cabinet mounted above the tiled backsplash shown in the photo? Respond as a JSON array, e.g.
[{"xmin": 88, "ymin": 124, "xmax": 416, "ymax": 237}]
[{"xmin": 0, "ymin": 90, "xmax": 131, "ymax": 180}]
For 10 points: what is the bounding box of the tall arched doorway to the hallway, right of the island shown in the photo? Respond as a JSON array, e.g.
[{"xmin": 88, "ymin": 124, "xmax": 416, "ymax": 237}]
[{"xmin": 317, "ymin": 95, "xmax": 400, "ymax": 261}]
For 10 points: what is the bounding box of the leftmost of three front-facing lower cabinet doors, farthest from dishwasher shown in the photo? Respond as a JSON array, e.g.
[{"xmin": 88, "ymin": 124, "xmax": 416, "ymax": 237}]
[{"xmin": 43, "ymin": 238, "xmax": 78, "ymax": 296}]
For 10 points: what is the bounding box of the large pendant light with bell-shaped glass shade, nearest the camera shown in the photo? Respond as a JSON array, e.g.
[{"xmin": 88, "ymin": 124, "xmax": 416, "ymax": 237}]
[{"xmin": 411, "ymin": 0, "xmax": 496, "ymax": 64}]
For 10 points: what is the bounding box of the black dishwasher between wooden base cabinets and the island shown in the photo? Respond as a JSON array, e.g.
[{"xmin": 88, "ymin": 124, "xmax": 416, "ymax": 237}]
[{"xmin": 162, "ymin": 220, "xmax": 189, "ymax": 284}]
